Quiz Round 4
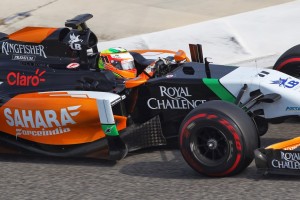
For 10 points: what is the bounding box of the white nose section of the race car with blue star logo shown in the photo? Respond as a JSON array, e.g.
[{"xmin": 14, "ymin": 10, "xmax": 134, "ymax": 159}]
[{"xmin": 220, "ymin": 68, "xmax": 300, "ymax": 120}]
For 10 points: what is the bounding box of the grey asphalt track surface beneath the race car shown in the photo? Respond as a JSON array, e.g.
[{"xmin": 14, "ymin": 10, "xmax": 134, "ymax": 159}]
[{"xmin": 0, "ymin": 120, "xmax": 300, "ymax": 200}]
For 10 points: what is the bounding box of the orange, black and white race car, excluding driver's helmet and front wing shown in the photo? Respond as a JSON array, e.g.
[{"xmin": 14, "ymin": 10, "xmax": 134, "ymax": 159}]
[{"xmin": 0, "ymin": 14, "xmax": 300, "ymax": 176}]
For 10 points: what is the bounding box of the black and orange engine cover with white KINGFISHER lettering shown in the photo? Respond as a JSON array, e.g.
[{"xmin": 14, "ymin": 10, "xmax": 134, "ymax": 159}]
[{"xmin": 0, "ymin": 15, "xmax": 98, "ymax": 69}]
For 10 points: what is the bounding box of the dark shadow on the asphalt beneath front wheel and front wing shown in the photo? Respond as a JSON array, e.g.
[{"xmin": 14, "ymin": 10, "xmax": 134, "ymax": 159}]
[{"xmin": 119, "ymin": 150, "xmax": 300, "ymax": 181}]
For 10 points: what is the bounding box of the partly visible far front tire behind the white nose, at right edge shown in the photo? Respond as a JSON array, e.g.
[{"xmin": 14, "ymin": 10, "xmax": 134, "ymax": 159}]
[{"xmin": 273, "ymin": 45, "xmax": 300, "ymax": 78}]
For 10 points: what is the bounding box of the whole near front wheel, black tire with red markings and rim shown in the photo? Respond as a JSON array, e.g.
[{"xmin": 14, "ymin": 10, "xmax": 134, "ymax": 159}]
[{"xmin": 179, "ymin": 101, "xmax": 259, "ymax": 177}]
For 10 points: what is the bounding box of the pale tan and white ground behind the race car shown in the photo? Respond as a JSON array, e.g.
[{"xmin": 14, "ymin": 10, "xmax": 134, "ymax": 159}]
[{"xmin": 0, "ymin": 0, "xmax": 300, "ymax": 67}]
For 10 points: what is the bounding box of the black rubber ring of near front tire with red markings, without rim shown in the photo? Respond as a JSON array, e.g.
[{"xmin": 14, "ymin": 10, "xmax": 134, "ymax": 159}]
[{"xmin": 179, "ymin": 101, "xmax": 258, "ymax": 176}]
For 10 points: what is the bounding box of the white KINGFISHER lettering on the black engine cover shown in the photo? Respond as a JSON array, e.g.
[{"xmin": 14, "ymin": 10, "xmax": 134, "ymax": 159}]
[{"xmin": 2, "ymin": 42, "xmax": 47, "ymax": 58}]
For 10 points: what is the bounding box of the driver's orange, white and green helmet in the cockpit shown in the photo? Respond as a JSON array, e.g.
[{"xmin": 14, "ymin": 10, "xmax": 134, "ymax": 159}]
[{"xmin": 98, "ymin": 47, "xmax": 137, "ymax": 78}]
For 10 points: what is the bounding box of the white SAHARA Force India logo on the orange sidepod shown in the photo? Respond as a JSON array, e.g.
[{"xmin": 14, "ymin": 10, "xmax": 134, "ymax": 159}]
[{"xmin": 4, "ymin": 105, "xmax": 80, "ymax": 137}]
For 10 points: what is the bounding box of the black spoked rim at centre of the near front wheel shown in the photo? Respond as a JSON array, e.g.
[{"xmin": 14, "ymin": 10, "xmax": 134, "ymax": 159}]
[{"xmin": 190, "ymin": 127, "xmax": 229, "ymax": 167}]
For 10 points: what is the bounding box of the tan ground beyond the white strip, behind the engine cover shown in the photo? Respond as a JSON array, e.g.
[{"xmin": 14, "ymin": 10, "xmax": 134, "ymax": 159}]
[{"xmin": 0, "ymin": 0, "xmax": 290, "ymax": 41}]
